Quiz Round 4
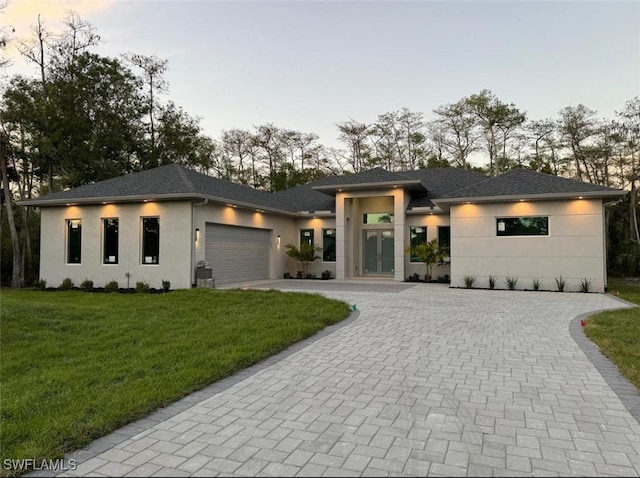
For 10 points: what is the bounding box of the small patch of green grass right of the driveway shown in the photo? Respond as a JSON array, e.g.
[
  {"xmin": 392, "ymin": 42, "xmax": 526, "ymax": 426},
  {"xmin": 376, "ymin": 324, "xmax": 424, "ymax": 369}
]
[{"xmin": 584, "ymin": 280, "xmax": 640, "ymax": 390}]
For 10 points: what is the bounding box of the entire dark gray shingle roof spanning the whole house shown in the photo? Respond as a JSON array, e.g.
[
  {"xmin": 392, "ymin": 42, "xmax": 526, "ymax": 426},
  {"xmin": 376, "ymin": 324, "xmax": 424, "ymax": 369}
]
[{"xmin": 22, "ymin": 164, "xmax": 624, "ymax": 213}]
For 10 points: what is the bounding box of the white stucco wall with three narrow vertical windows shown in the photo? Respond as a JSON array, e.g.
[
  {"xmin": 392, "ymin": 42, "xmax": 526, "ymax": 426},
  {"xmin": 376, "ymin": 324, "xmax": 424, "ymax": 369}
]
[{"xmin": 40, "ymin": 201, "xmax": 192, "ymax": 289}]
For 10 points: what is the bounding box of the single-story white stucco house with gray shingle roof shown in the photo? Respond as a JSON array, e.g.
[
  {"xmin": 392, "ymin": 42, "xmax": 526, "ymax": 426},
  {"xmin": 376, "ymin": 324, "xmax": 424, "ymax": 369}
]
[{"xmin": 22, "ymin": 165, "xmax": 625, "ymax": 292}]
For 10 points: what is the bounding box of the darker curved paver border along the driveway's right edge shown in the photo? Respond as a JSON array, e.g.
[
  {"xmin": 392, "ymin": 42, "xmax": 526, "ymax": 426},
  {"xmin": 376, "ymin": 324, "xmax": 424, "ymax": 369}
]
[{"xmin": 569, "ymin": 294, "xmax": 640, "ymax": 425}]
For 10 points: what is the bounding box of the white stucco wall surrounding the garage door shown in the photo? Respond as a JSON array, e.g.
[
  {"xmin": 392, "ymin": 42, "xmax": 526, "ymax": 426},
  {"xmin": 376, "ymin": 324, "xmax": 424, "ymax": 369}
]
[{"xmin": 190, "ymin": 203, "xmax": 296, "ymax": 281}]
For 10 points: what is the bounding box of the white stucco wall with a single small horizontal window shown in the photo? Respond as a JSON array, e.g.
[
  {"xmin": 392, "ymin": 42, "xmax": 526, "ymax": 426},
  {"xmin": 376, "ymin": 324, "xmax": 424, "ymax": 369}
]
[{"xmin": 450, "ymin": 199, "xmax": 606, "ymax": 292}]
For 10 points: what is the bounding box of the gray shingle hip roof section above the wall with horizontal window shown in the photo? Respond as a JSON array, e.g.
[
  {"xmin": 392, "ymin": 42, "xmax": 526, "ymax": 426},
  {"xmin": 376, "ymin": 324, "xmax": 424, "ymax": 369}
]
[{"xmin": 440, "ymin": 169, "xmax": 624, "ymax": 202}]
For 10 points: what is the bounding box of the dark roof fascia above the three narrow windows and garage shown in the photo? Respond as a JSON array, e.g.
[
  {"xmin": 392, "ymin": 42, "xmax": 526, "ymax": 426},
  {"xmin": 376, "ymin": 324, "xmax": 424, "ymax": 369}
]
[{"xmin": 18, "ymin": 193, "xmax": 299, "ymax": 217}]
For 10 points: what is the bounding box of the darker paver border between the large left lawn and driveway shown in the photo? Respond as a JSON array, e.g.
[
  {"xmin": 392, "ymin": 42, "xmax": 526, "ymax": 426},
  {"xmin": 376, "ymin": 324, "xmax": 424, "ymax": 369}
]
[{"xmin": 31, "ymin": 304, "xmax": 360, "ymax": 476}]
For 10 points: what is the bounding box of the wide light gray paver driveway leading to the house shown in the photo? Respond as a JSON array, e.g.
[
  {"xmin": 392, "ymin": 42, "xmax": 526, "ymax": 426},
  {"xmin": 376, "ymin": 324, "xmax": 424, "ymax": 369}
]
[{"xmin": 57, "ymin": 281, "xmax": 640, "ymax": 476}]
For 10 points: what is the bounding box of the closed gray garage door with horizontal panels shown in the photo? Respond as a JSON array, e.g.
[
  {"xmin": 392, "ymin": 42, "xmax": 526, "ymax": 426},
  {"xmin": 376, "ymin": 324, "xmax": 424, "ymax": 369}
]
[{"xmin": 205, "ymin": 224, "xmax": 271, "ymax": 284}]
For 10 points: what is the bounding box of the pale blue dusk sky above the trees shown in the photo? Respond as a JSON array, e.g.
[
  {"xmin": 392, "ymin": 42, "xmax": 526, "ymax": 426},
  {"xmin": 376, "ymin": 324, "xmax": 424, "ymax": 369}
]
[{"xmin": 9, "ymin": 0, "xmax": 640, "ymax": 145}]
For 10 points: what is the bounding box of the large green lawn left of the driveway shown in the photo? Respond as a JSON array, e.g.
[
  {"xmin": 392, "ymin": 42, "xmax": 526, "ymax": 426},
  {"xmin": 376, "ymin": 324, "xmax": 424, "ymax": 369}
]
[{"xmin": 0, "ymin": 289, "xmax": 349, "ymax": 474}]
